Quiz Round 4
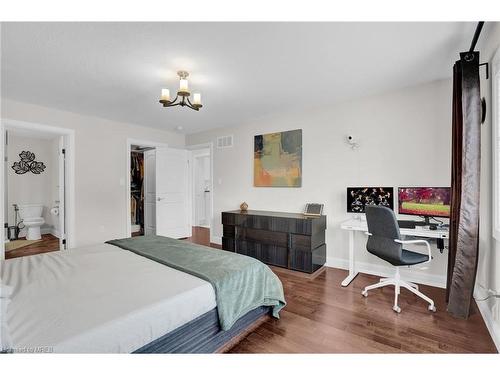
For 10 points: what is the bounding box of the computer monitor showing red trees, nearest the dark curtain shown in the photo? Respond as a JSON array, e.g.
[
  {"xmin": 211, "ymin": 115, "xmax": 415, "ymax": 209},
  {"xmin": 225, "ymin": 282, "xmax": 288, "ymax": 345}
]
[{"xmin": 398, "ymin": 187, "xmax": 451, "ymax": 225}]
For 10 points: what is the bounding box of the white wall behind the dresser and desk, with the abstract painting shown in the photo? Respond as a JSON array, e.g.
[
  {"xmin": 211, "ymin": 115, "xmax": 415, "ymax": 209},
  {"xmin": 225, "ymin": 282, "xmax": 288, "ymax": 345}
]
[{"xmin": 186, "ymin": 80, "xmax": 452, "ymax": 286}]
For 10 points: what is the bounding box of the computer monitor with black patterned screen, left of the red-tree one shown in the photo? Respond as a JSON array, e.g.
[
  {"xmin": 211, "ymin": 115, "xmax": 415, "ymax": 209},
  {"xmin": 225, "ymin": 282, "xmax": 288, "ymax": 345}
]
[{"xmin": 347, "ymin": 187, "xmax": 394, "ymax": 213}]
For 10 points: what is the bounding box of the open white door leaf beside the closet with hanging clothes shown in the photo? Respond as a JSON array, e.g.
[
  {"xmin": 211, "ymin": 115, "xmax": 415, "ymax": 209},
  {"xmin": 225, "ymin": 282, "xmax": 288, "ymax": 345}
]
[{"xmin": 156, "ymin": 148, "xmax": 191, "ymax": 238}]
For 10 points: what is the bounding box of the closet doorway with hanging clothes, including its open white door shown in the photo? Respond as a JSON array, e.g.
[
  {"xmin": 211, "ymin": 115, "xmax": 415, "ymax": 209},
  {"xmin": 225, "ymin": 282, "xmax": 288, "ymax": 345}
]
[{"xmin": 125, "ymin": 139, "xmax": 192, "ymax": 239}]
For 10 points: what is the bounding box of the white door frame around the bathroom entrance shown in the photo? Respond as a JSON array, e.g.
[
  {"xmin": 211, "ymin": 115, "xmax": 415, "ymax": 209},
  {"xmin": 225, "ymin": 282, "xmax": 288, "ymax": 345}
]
[{"xmin": 0, "ymin": 118, "xmax": 76, "ymax": 260}]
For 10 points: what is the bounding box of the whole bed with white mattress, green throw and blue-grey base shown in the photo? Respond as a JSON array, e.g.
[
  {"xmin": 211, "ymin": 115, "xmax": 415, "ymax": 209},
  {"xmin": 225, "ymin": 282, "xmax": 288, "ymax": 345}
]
[{"xmin": 2, "ymin": 236, "xmax": 285, "ymax": 353}]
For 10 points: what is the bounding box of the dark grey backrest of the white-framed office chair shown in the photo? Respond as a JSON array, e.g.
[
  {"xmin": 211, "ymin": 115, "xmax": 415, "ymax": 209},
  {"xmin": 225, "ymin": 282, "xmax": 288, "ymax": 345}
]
[{"xmin": 365, "ymin": 205, "xmax": 403, "ymax": 265}]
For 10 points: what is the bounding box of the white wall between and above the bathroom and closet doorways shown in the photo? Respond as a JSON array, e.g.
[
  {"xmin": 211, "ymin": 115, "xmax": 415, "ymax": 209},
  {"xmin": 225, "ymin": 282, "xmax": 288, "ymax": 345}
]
[{"xmin": 1, "ymin": 98, "xmax": 184, "ymax": 246}]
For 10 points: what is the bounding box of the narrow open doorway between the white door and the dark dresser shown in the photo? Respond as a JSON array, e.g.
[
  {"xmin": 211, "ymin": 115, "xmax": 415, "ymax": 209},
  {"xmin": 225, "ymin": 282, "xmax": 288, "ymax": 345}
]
[{"xmin": 189, "ymin": 143, "xmax": 213, "ymax": 246}]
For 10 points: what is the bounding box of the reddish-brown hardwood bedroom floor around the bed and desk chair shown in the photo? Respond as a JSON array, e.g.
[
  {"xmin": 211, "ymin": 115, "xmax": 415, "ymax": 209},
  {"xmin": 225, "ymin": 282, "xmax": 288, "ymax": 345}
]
[{"xmin": 188, "ymin": 227, "xmax": 497, "ymax": 353}]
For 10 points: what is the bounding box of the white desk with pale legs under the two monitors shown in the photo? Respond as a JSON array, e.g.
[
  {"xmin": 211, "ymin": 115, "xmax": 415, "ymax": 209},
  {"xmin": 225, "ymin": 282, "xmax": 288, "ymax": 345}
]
[{"xmin": 340, "ymin": 219, "xmax": 449, "ymax": 286}]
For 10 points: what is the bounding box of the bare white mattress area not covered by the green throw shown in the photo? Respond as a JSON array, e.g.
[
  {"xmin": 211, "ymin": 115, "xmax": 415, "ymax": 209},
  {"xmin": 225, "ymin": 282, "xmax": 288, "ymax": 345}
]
[{"xmin": 2, "ymin": 244, "xmax": 216, "ymax": 353}]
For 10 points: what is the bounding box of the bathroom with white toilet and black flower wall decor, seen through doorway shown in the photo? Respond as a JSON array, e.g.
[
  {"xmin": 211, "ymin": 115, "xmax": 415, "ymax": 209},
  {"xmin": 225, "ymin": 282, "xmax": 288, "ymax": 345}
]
[{"xmin": 4, "ymin": 129, "xmax": 64, "ymax": 259}]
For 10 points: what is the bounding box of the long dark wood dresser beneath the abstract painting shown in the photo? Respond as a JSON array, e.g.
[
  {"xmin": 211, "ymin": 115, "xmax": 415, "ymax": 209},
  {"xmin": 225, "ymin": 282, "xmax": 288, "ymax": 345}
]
[{"xmin": 222, "ymin": 210, "xmax": 326, "ymax": 273}]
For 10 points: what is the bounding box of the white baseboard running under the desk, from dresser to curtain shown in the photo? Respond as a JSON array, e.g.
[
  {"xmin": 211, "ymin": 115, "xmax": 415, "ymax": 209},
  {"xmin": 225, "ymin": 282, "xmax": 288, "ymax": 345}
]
[{"xmin": 326, "ymin": 257, "xmax": 446, "ymax": 288}]
